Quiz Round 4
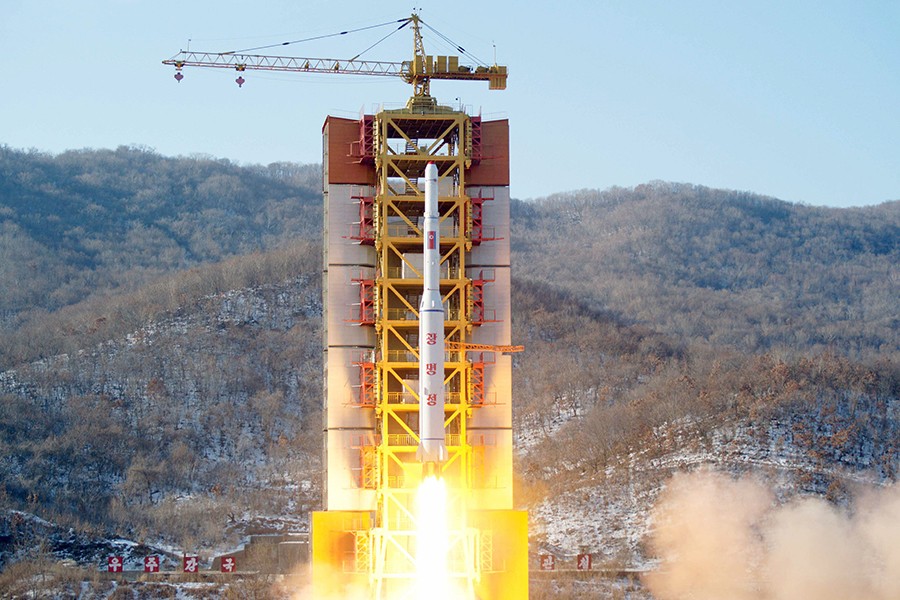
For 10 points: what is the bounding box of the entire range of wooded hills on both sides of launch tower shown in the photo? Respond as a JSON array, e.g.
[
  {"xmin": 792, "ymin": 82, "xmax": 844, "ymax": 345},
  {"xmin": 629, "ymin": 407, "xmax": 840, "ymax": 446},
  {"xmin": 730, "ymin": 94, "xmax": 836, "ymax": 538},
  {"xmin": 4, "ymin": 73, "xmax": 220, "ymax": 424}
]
[{"xmin": 0, "ymin": 148, "xmax": 900, "ymax": 596}]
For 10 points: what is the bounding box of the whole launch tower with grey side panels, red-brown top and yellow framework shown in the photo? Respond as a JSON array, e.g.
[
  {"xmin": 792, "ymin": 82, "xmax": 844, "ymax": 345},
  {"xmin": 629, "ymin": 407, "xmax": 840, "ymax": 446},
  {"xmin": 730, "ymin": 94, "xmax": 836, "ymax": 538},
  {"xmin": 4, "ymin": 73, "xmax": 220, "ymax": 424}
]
[{"xmin": 312, "ymin": 91, "xmax": 528, "ymax": 598}]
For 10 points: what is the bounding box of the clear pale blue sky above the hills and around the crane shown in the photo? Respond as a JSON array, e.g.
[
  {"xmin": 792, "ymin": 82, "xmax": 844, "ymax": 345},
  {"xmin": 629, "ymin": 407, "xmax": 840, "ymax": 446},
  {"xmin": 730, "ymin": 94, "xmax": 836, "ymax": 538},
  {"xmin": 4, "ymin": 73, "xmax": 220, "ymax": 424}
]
[{"xmin": 0, "ymin": 0, "xmax": 900, "ymax": 206}]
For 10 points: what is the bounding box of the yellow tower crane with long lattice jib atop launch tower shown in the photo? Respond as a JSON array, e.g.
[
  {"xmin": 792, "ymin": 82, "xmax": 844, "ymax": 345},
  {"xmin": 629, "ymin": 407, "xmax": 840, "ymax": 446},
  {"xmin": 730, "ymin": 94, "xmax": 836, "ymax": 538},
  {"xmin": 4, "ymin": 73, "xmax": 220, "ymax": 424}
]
[{"xmin": 162, "ymin": 13, "xmax": 507, "ymax": 100}]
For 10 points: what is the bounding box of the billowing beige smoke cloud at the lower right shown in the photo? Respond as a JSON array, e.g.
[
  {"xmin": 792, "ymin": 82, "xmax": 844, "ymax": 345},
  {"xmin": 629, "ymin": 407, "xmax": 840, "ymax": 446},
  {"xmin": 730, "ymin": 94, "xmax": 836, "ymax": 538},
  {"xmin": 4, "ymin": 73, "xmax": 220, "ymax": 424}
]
[{"xmin": 646, "ymin": 471, "xmax": 900, "ymax": 600}]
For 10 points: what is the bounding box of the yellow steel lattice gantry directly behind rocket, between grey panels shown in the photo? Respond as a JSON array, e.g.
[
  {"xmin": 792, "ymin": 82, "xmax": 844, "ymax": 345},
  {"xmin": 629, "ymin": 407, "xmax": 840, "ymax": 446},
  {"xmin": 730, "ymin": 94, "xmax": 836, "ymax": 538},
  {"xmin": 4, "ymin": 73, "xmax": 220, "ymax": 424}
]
[{"xmin": 361, "ymin": 105, "xmax": 481, "ymax": 597}]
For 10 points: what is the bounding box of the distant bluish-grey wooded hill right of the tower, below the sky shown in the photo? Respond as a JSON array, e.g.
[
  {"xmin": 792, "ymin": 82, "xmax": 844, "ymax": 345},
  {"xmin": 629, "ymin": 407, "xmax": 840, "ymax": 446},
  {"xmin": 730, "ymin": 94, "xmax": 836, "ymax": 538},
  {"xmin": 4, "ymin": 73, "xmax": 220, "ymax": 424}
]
[{"xmin": 511, "ymin": 182, "xmax": 900, "ymax": 357}]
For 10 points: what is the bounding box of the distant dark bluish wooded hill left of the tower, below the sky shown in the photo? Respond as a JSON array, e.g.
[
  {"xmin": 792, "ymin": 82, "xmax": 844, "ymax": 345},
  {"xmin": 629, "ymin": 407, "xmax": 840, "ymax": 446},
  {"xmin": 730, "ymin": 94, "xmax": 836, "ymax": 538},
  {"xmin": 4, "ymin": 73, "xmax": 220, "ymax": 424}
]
[{"xmin": 0, "ymin": 146, "xmax": 321, "ymax": 336}]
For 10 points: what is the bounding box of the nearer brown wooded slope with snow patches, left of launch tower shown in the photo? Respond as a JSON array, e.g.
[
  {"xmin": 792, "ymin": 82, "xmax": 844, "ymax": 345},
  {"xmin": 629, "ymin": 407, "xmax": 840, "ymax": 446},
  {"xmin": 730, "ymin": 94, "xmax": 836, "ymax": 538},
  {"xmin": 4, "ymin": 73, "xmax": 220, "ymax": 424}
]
[{"xmin": 0, "ymin": 242, "xmax": 322, "ymax": 553}]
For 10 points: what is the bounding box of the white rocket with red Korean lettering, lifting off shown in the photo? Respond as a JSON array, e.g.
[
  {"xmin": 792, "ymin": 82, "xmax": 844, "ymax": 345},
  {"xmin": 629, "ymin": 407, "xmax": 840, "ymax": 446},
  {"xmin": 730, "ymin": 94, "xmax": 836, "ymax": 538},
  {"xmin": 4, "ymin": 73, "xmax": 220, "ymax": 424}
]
[{"xmin": 416, "ymin": 163, "xmax": 447, "ymax": 475}]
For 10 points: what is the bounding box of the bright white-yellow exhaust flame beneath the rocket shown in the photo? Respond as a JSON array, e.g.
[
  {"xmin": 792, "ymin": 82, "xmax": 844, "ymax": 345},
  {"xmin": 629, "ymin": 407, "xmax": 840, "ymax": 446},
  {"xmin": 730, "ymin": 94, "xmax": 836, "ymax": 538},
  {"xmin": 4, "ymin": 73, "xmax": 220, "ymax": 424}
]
[{"xmin": 416, "ymin": 475, "xmax": 451, "ymax": 600}]
